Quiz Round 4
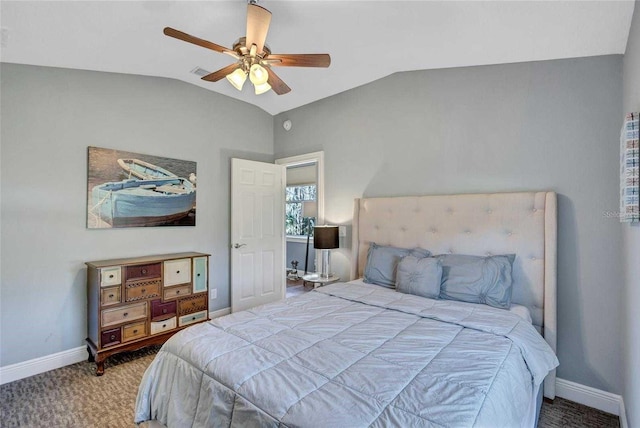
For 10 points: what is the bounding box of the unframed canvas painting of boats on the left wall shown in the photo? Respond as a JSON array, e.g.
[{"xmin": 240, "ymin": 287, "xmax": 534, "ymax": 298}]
[{"xmin": 87, "ymin": 147, "xmax": 196, "ymax": 229}]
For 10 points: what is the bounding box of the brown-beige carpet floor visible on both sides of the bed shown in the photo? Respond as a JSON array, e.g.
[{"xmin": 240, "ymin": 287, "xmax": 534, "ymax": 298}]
[{"xmin": 0, "ymin": 347, "xmax": 620, "ymax": 428}]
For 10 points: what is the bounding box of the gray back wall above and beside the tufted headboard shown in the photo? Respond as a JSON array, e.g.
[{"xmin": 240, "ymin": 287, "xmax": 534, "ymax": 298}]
[{"xmin": 274, "ymin": 56, "xmax": 623, "ymax": 393}]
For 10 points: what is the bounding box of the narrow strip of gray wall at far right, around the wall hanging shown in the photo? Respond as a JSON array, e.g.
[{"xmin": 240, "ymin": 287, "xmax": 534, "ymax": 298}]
[{"xmin": 618, "ymin": 1, "xmax": 640, "ymax": 427}]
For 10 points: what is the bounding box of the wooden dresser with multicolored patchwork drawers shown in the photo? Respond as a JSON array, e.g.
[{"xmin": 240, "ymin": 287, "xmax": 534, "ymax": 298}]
[{"xmin": 86, "ymin": 252, "xmax": 209, "ymax": 376}]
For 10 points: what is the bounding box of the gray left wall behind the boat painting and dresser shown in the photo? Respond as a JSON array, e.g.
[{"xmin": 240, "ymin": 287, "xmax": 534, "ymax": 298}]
[{"xmin": 0, "ymin": 64, "xmax": 273, "ymax": 366}]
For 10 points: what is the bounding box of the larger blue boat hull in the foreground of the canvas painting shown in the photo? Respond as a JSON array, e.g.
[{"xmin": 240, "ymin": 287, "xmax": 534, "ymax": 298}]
[{"xmin": 91, "ymin": 177, "xmax": 196, "ymax": 227}]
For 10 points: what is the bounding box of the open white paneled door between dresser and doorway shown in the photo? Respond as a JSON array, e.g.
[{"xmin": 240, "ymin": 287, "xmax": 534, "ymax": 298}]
[{"xmin": 231, "ymin": 159, "xmax": 286, "ymax": 312}]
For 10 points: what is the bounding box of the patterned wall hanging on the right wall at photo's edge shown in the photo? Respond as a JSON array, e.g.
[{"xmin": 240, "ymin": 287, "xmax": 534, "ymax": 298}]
[{"xmin": 620, "ymin": 113, "xmax": 640, "ymax": 222}]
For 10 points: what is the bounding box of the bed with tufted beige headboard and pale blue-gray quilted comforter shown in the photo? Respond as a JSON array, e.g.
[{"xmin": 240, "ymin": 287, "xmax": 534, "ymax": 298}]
[{"xmin": 135, "ymin": 192, "xmax": 558, "ymax": 427}]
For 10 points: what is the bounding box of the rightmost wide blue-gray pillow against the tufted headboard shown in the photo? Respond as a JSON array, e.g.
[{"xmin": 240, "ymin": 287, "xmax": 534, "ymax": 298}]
[{"xmin": 437, "ymin": 254, "xmax": 516, "ymax": 309}]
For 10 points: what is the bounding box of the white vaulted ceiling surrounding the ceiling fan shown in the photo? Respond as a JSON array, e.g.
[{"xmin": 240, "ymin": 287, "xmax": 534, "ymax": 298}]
[{"xmin": 0, "ymin": 0, "xmax": 634, "ymax": 115}]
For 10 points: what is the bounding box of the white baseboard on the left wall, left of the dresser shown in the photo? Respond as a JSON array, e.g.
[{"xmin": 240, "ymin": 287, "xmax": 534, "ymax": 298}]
[{"xmin": 0, "ymin": 346, "xmax": 89, "ymax": 385}]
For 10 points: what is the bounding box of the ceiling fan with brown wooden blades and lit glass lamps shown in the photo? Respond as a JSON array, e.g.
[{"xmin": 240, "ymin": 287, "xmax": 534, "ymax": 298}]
[{"xmin": 164, "ymin": 0, "xmax": 331, "ymax": 95}]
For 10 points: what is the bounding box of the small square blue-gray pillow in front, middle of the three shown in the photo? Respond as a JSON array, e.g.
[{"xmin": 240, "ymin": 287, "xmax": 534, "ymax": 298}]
[{"xmin": 396, "ymin": 256, "xmax": 442, "ymax": 299}]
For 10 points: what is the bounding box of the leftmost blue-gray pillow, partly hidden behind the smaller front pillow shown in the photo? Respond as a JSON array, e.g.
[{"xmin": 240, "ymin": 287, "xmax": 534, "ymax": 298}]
[{"xmin": 363, "ymin": 242, "xmax": 431, "ymax": 288}]
